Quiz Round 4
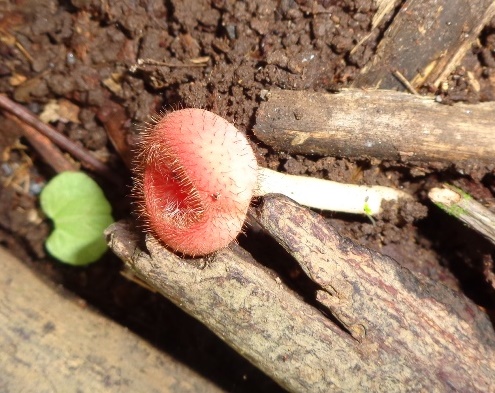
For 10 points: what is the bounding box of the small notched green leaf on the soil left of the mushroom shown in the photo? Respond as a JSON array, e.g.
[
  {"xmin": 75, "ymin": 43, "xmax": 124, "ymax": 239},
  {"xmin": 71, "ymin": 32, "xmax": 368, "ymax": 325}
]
[{"xmin": 40, "ymin": 172, "xmax": 113, "ymax": 265}]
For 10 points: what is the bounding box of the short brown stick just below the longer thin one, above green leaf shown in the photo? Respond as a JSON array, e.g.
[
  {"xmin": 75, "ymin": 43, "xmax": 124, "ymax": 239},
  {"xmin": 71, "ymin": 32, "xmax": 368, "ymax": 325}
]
[{"xmin": 4, "ymin": 112, "xmax": 77, "ymax": 173}]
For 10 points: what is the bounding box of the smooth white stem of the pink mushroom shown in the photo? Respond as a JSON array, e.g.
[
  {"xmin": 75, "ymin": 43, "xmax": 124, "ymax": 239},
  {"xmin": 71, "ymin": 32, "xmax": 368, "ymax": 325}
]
[{"xmin": 254, "ymin": 167, "xmax": 411, "ymax": 215}]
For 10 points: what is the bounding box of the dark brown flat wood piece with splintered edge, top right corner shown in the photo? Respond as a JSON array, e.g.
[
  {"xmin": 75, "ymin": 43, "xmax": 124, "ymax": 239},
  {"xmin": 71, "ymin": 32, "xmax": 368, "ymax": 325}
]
[{"xmin": 353, "ymin": 0, "xmax": 495, "ymax": 90}]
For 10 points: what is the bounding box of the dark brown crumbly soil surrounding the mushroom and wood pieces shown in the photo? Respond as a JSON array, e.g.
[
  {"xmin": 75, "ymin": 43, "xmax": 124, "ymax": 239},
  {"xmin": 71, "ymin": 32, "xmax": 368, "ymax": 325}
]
[{"xmin": 0, "ymin": 0, "xmax": 495, "ymax": 392}]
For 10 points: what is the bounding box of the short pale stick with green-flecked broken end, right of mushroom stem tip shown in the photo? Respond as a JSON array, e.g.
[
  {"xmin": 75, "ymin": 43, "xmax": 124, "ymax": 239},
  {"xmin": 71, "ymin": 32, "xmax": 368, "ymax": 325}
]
[{"xmin": 428, "ymin": 185, "xmax": 495, "ymax": 244}]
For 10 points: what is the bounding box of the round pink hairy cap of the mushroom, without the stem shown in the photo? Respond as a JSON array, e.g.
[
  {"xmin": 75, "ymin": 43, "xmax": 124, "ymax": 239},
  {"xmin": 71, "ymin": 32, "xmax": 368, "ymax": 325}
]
[{"xmin": 137, "ymin": 108, "xmax": 257, "ymax": 256}]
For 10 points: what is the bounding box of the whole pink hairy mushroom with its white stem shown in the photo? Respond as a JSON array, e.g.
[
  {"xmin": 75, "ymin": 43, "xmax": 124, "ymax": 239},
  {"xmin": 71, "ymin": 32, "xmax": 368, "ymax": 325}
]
[{"xmin": 136, "ymin": 108, "xmax": 408, "ymax": 256}]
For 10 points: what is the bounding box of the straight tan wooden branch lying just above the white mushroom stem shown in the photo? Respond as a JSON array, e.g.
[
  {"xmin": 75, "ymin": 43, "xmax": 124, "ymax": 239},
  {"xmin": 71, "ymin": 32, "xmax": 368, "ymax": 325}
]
[{"xmin": 254, "ymin": 89, "xmax": 495, "ymax": 164}]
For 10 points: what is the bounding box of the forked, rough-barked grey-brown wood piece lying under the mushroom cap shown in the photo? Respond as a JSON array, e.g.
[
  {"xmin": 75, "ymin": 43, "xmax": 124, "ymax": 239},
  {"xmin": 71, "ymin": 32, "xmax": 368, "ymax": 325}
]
[{"xmin": 107, "ymin": 201, "xmax": 495, "ymax": 392}]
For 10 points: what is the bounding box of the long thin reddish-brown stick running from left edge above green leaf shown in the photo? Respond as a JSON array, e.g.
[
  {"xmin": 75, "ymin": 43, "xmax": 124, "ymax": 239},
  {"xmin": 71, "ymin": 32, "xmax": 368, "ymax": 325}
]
[{"xmin": 0, "ymin": 94, "xmax": 120, "ymax": 184}]
